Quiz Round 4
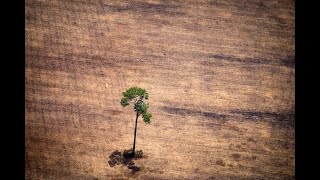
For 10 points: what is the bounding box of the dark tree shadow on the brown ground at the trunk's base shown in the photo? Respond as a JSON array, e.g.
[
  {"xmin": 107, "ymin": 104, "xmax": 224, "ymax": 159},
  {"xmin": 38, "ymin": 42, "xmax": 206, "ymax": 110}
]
[{"xmin": 108, "ymin": 150, "xmax": 140, "ymax": 174}]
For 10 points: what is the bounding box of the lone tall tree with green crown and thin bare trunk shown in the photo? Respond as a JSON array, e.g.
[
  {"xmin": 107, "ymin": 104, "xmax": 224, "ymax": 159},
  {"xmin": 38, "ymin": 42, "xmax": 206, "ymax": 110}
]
[{"xmin": 121, "ymin": 87, "xmax": 152, "ymax": 157}]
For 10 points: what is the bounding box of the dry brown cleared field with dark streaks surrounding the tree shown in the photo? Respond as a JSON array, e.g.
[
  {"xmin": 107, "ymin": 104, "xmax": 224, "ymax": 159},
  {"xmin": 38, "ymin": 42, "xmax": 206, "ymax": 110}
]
[{"xmin": 25, "ymin": 0, "xmax": 295, "ymax": 179}]
